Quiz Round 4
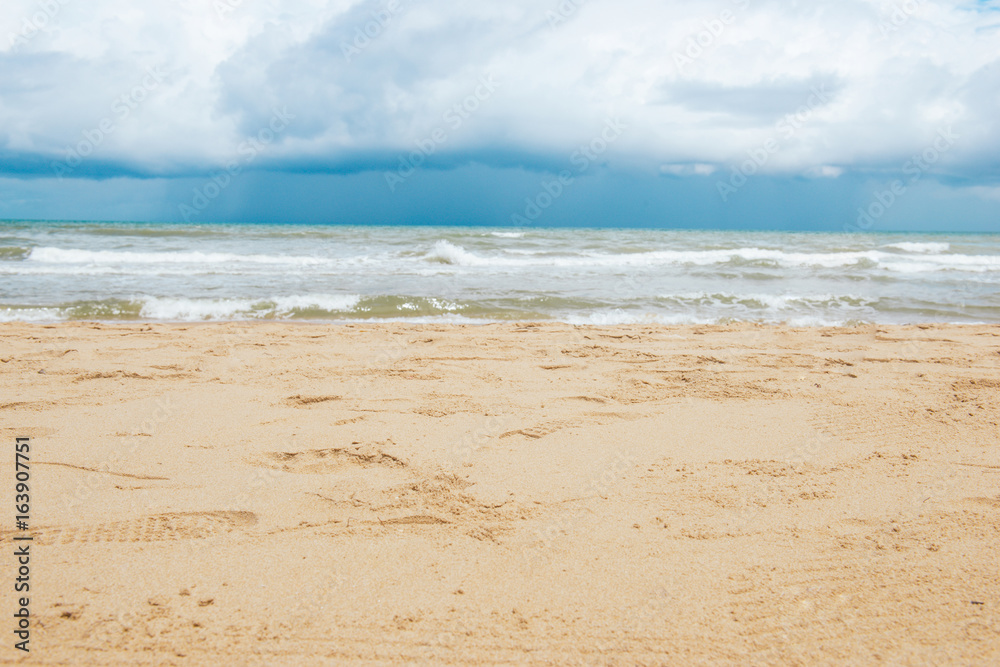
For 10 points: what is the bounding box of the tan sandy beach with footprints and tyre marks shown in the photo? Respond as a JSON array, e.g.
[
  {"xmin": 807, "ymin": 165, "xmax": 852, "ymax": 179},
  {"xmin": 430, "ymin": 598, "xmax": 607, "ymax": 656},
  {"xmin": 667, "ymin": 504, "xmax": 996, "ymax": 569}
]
[{"xmin": 0, "ymin": 323, "xmax": 1000, "ymax": 665}]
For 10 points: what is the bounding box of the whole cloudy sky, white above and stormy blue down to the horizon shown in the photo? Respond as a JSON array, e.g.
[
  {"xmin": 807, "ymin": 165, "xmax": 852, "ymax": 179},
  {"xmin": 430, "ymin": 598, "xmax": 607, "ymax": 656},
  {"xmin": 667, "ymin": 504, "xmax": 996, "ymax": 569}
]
[{"xmin": 0, "ymin": 0, "xmax": 1000, "ymax": 232}]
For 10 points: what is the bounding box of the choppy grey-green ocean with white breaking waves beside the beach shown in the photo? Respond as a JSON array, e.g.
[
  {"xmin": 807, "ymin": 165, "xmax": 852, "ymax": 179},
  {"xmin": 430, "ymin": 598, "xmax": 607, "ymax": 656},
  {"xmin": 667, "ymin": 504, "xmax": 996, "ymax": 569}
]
[{"xmin": 0, "ymin": 222, "xmax": 1000, "ymax": 326}]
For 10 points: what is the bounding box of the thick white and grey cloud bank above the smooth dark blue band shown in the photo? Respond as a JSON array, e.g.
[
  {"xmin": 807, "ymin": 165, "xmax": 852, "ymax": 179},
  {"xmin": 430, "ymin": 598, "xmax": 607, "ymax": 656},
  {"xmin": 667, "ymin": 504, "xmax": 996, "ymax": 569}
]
[{"xmin": 0, "ymin": 0, "xmax": 1000, "ymax": 181}]
